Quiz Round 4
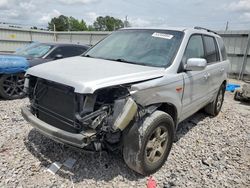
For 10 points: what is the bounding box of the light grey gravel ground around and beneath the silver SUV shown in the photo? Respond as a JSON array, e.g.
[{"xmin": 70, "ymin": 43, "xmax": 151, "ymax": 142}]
[{"xmin": 0, "ymin": 93, "xmax": 250, "ymax": 188}]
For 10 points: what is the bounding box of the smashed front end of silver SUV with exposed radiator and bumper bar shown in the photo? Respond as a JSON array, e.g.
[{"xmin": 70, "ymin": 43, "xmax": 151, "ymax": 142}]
[{"xmin": 22, "ymin": 76, "xmax": 140, "ymax": 151}]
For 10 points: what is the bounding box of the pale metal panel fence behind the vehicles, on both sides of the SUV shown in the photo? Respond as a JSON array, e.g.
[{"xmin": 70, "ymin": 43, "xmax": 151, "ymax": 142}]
[{"xmin": 0, "ymin": 27, "xmax": 250, "ymax": 80}]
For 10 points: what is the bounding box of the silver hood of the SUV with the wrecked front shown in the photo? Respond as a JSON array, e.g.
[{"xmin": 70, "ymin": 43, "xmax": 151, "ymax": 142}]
[{"xmin": 27, "ymin": 56, "xmax": 165, "ymax": 93}]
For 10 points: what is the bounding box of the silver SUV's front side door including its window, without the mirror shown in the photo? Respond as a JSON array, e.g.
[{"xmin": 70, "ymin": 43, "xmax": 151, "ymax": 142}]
[{"xmin": 181, "ymin": 34, "xmax": 209, "ymax": 120}]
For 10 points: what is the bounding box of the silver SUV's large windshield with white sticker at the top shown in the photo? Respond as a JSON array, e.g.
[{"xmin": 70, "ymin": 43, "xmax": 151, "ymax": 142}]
[{"xmin": 85, "ymin": 29, "xmax": 183, "ymax": 67}]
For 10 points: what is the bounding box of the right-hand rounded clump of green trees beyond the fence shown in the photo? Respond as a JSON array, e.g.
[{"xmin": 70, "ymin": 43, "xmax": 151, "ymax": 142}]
[{"xmin": 93, "ymin": 16, "xmax": 124, "ymax": 31}]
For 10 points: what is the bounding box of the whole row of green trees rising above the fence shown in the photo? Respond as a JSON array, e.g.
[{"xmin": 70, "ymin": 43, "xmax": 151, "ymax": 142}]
[{"xmin": 46, "ymin": 15, "xmax": 130, "ymax": 31}]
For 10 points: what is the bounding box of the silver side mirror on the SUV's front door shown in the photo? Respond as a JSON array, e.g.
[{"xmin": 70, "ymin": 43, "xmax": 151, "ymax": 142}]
[{"xmin": 185, "ymin": 58, "xmax": 207, "ymax": 71}]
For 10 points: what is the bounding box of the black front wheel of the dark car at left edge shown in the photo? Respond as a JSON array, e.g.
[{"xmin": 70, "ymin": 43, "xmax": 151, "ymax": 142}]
[{"xmin": 0, "ymin": 73, "xmax": 25, "ymax": 100}]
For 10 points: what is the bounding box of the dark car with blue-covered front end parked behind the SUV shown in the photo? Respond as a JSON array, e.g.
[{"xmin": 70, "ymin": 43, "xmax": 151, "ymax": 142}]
[{"xmin": 0, "ymin": 42, "xmax": 88, "ymax": 99}]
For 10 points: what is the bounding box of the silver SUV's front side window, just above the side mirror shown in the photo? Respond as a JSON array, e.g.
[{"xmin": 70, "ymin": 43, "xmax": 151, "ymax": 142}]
[{"xmin": 182, "ymin": 35, "xmax": 204, "ymax": 63}]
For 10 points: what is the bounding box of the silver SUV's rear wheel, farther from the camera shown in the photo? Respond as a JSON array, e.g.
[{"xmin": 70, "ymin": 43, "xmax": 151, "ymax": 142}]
[{"xmin": 205, "ymin": 84, "xmax": 226, "ymax": 117}]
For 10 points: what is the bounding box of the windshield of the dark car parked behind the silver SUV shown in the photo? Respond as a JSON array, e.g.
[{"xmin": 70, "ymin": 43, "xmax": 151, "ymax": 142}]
[{"xmin": 15, "ymin": 44, "xmax": 52, "ymax": 57}]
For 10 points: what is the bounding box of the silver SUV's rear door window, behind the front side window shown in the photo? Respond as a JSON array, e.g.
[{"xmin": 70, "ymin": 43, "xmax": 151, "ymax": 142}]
[{"xmin": 204, "ymin": 36, "xmax": 220, "ymax": 63}]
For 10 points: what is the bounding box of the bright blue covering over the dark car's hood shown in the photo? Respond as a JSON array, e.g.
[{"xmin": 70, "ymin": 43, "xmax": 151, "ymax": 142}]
[{"xmin": 0, "ymin": 54, "xmax": 29, "ymax": 74}]
